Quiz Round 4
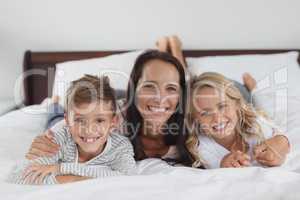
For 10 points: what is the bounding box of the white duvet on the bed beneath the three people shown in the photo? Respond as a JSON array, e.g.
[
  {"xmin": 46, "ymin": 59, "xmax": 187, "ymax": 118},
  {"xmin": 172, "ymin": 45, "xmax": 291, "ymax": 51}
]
[{"xmin": 0, "ymin": 98, "xmax": 300, "ymax": 200}]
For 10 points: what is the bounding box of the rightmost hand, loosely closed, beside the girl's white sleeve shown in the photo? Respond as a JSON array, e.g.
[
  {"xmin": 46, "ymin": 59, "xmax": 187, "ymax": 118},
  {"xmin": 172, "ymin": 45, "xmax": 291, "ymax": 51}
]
[{"xmin": 253, "ymin": 135, "xmax": 290, "ymax": 167}]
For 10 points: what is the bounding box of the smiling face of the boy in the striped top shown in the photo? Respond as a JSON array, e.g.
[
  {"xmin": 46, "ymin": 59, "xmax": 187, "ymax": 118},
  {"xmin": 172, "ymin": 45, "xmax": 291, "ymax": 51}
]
[{"xmin": 66, "ymin": 101, "xmax": 116, "ymax": 156}]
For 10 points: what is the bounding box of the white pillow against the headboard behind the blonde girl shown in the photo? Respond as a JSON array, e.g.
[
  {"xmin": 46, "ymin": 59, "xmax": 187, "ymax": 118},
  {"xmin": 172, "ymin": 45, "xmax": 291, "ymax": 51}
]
[{"xmin": 186, "ymin": 51, "xmax": 300, "ymax": 96}]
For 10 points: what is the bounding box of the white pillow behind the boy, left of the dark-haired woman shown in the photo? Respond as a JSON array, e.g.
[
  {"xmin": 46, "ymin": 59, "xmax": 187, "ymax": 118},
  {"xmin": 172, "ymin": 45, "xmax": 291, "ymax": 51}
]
[{"xmin": 52, "ymin": 50, "xmax": 144, "ymax": 105}]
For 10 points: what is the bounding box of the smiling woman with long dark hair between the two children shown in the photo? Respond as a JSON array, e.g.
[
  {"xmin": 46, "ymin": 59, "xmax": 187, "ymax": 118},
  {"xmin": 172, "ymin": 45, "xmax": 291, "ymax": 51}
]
[{"xmin": 26, "ymin": 50, "xmax": 193, "ymax": 166}]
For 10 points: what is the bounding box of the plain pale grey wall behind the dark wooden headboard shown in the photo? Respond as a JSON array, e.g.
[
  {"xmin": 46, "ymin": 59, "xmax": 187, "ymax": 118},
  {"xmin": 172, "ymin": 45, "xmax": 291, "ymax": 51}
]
[{"xmin": 0, "ymin": 0, "xmax": 300, "ymax": 100}]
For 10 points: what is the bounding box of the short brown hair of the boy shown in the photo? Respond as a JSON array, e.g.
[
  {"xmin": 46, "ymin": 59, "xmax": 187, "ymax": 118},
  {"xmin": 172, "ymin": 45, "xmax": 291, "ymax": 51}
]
[{"xmin": 65, "ymin": 74, "xmax": 116, "ymax": 113}]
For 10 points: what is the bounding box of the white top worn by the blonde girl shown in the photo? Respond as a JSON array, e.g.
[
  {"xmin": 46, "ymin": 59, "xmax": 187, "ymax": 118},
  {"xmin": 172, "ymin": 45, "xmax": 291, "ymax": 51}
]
[{"xmin": 198, "ymin": 117, "xmax": 281, "ymax": 169}]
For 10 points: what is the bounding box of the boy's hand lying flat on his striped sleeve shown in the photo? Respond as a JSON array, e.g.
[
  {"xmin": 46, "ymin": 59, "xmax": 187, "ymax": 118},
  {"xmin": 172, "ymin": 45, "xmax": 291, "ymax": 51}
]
[{"xmin": 23, "ymin": 164, "xmax": 60, "ymax": 184}]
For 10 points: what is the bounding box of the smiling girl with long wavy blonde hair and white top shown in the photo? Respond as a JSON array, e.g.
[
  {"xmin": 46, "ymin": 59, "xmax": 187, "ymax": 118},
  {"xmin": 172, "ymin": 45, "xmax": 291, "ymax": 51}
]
[{"xmin": 187, "ymin": 72, "xmax": 289, "ymax": 168}]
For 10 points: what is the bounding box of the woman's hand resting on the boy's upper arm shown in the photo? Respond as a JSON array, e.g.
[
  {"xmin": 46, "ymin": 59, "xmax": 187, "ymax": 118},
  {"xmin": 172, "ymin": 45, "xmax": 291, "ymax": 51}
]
[{"xmin": 26, "ymin": 130, "xmax": 60, "ymax": 160}]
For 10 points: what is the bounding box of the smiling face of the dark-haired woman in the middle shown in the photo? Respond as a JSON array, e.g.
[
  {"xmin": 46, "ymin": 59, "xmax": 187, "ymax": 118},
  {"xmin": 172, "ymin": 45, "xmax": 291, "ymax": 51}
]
[{"xmin": 135, "ymin": 60, "xmax": 181, "ymax": 134}]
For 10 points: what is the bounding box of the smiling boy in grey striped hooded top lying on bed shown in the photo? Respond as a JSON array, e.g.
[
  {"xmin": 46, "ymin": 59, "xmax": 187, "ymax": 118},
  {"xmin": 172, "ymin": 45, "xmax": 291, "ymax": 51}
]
[{"xmin": 9, "ymin": 75, "xmax": 136, "ymax": 184}]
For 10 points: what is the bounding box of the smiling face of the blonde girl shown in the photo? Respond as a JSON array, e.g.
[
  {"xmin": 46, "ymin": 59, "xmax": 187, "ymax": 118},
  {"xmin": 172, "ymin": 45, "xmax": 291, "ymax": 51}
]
[{"xmin": 193, "ymin": 87, "xmax": 238, "ymax": 139}]
